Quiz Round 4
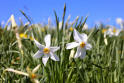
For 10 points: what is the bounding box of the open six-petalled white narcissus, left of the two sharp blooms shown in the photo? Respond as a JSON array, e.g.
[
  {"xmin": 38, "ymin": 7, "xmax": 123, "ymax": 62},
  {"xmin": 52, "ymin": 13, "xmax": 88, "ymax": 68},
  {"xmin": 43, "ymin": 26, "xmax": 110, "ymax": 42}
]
[{"xmin": 33, "ymin": 34, "xmax": 60, "ymax": 66}]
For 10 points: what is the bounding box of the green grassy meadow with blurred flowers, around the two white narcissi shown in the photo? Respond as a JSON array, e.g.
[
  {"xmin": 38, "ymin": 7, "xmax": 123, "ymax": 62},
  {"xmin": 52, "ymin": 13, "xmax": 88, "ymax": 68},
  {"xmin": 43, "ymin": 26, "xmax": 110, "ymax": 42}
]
[{"xmin": 0, "ymin": 5, "xmax": 124, "ymax": 83}]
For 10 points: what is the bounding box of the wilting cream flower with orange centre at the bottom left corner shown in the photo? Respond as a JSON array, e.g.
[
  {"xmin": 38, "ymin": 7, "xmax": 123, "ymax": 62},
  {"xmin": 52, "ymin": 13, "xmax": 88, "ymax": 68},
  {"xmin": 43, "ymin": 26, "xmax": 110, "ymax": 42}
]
[{"xmin": 5, "ymin": 64, "xmax": 41, "ymax": 83}]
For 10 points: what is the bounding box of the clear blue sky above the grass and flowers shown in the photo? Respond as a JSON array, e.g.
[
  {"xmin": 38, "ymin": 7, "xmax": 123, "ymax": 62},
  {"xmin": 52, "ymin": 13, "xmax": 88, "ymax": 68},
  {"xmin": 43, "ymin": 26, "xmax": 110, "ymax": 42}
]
[{"xmin": 0, "ymin": 0, "xmax": 124, "ymax": 26}]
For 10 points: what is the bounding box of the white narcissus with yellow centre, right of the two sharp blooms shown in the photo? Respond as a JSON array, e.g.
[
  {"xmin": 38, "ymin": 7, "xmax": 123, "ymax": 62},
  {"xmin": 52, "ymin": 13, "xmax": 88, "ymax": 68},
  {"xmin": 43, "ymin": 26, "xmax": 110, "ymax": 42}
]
[{"xmin": 66, "ymin": 29, "xmax": 92, "ymax": 59}]
